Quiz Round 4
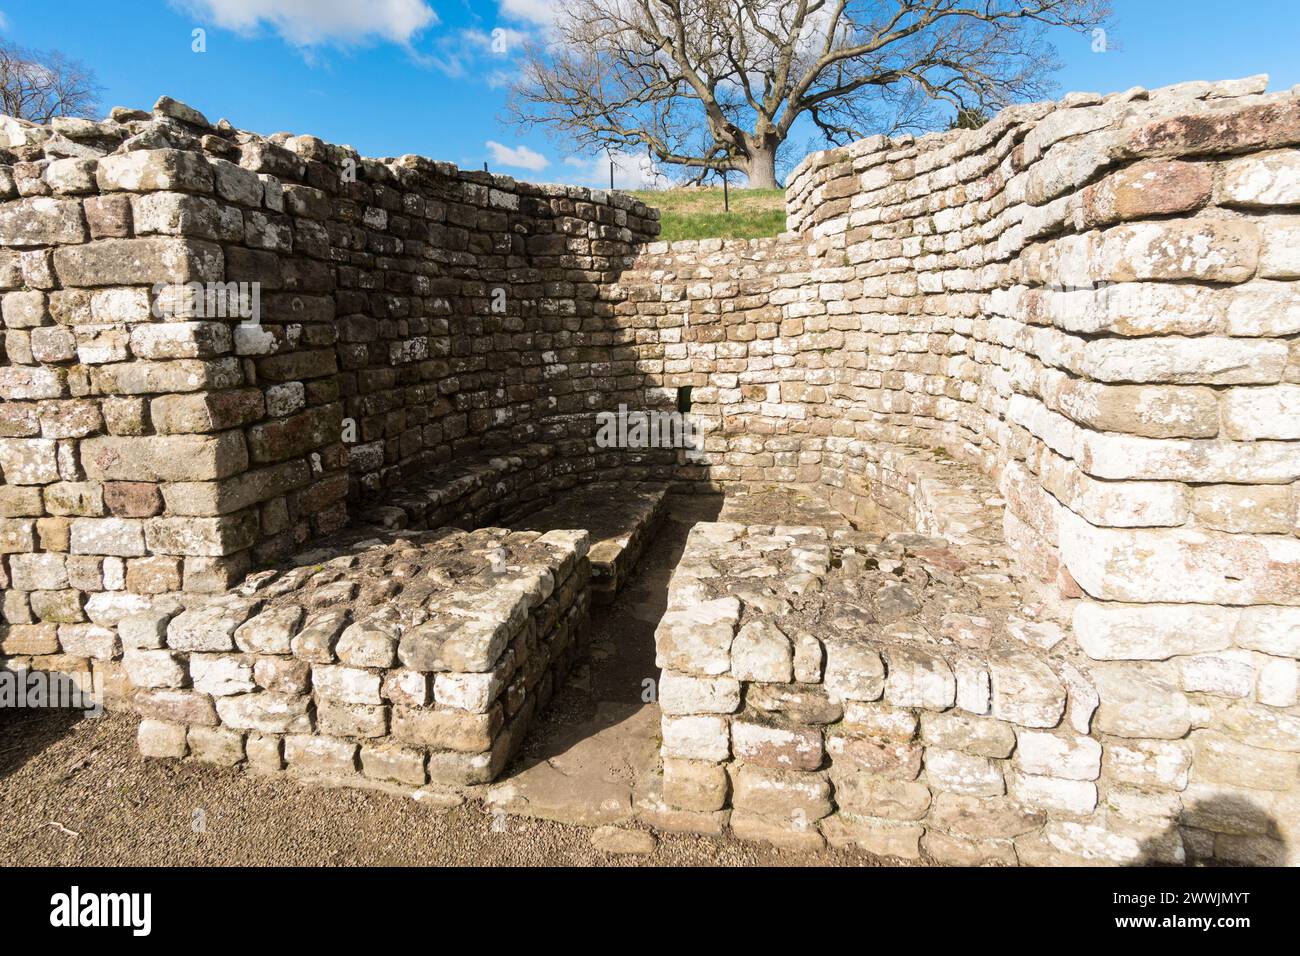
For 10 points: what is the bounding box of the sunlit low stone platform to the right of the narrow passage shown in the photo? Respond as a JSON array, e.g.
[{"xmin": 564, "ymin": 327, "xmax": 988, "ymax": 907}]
[{"xmin": 653, "ymin": 523, "xmax": 1170, "ymax": 864}]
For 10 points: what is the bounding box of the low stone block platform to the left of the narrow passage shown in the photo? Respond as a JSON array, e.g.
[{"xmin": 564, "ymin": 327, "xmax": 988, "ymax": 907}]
[{"xmin": 130, "ymin": 528, "xmax": 590, "ymax": 791}]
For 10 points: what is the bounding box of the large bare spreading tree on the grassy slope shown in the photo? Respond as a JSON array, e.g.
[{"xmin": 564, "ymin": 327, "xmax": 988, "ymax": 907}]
[{"xmin": 510, "ymin": 0, "xmax": 1110, "ymax": 187}]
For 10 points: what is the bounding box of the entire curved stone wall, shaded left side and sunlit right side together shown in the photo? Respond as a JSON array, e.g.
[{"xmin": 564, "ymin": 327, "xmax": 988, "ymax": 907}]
[{"xmin": 0, "ymin": 78, "xmax": 1300, "ymax": 860}]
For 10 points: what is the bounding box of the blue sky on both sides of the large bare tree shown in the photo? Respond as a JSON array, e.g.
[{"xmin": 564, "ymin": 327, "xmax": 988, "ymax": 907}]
[{"xmin": 0, "ymin": 0, "xmax": 1300, "ymax": 185}]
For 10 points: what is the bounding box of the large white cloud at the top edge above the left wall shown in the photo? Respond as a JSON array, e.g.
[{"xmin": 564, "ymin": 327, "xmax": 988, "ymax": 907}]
[{"xmin": 178, "ymin": 0, "xmax": 438, "ymax": 47}]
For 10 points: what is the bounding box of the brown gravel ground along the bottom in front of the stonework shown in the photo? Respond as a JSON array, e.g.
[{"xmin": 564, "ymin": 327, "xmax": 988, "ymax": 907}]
[{"xmin": 0, "ymin": 710, "xmax": 879, "ymax": 866}]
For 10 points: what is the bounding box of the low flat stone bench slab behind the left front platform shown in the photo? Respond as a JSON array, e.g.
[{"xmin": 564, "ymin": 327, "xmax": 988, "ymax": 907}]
[{"xmin": 511, "ymin": 481, "xmax": 666, "ymax": 604}]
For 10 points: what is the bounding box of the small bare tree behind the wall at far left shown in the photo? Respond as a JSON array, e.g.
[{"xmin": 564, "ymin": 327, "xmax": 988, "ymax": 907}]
[{"xmin": 0, "ymin": 40, "xmax": 101, "ymax": 124}]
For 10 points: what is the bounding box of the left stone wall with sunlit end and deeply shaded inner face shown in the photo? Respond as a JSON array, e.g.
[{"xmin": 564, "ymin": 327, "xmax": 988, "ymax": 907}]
[{"xmin": 0, "ymin": 98, "xmax": 658, "ymax": 689}]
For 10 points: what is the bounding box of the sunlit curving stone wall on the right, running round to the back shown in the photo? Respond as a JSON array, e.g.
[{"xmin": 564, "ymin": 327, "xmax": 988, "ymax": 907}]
[{"xmin": 620, "ymin": 78, "xmax": 1300, "ymax": 860}]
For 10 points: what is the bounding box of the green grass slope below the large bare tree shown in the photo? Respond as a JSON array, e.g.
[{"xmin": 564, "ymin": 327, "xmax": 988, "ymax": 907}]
[{"xmin": 633, "ymin": 189, "xmax": 785, "ymax": 242}]
